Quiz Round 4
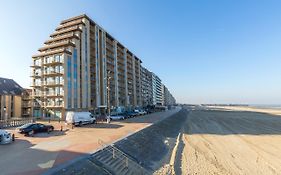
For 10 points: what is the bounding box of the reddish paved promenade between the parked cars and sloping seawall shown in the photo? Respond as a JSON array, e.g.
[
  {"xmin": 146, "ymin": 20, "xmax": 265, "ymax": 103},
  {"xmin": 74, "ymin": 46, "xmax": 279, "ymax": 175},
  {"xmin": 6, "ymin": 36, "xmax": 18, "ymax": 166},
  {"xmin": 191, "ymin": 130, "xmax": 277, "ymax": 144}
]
[{"xmin": 0, "ymin": 108, "xmax": 180, "ymax": 175}]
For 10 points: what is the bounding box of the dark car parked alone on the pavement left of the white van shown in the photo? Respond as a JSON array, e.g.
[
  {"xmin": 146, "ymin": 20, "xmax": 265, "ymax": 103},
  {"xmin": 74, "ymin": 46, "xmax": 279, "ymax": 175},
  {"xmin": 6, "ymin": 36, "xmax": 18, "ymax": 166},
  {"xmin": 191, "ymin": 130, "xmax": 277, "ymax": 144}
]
[{"xmin": 18, "ymin": 123, "xmax": 54, "ymax": 136}]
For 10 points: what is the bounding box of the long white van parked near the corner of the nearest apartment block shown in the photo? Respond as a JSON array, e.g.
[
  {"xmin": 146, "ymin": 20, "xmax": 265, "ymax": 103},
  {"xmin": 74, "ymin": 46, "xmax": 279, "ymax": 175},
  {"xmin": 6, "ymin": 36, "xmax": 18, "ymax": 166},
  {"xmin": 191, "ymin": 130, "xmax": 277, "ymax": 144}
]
[{"xmin": 65, "ymin": 111, "xmax": 96, "ymax": 126}]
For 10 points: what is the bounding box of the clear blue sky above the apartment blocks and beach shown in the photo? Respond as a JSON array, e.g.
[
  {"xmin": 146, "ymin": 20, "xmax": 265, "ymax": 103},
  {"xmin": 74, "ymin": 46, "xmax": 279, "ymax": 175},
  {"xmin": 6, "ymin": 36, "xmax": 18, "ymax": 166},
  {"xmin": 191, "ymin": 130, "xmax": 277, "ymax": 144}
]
[{"xmin": 0, "ymin": 0, "xmax": 281, "ymax": 104}]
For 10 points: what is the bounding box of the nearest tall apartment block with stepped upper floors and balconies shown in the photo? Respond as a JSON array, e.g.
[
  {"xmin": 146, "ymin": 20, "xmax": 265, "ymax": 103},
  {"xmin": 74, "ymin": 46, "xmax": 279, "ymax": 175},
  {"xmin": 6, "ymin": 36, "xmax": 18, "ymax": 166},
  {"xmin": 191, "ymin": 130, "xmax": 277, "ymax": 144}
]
[{"xmin": 31, "ymin": 15, "xmax": 142, "ymax": 118}]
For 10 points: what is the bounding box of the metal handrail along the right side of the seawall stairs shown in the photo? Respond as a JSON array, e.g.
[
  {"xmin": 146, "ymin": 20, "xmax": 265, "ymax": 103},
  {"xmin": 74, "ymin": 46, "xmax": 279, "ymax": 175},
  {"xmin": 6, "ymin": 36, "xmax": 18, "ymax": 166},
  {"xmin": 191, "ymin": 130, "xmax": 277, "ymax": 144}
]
[{"xmin": 98, "ymin": 139, "xmax": 151, "ymax": 175}]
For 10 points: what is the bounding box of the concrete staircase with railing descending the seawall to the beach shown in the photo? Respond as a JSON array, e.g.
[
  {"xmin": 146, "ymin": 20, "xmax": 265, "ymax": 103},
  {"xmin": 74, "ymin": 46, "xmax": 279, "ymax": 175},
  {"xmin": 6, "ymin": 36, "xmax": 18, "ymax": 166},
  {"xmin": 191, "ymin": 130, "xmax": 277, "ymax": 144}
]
[{"xmin": 89, "ymin": 140, "xmax": 152, "ymax": 175}]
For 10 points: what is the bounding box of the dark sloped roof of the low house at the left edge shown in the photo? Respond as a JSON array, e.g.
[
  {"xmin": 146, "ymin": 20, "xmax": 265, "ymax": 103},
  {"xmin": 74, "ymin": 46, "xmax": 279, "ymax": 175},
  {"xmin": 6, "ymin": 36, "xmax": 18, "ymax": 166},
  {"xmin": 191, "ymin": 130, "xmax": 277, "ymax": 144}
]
[{"xmin": 0, "ymin": 77, "xmax": 24, "ymax": 95}]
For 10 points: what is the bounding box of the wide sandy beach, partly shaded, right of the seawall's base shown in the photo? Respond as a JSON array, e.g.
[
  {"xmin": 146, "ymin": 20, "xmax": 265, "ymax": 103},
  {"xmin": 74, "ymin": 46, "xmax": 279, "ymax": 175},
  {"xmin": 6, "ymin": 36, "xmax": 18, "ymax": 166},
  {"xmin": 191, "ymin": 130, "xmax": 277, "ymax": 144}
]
[{"xmin": 175, "ymin": 107, "xmax": 281, "ymax": 175}]
